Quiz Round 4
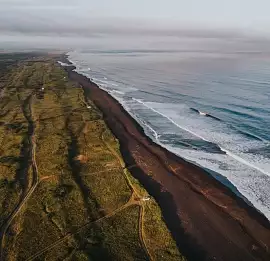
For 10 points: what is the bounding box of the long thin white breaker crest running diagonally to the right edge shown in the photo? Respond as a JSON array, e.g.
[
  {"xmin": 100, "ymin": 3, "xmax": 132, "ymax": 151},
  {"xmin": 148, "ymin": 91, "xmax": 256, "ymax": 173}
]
[{"xmin": 132, "ymin": 98, "xmax": 270, "ymax": 176}]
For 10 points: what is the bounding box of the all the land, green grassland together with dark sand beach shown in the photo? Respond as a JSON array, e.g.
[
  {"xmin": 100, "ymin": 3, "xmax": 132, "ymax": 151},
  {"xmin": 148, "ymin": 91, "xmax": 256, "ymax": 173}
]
[{"xmin": 0, "ymin": 53, "xmax": 270, "ymax": 261}]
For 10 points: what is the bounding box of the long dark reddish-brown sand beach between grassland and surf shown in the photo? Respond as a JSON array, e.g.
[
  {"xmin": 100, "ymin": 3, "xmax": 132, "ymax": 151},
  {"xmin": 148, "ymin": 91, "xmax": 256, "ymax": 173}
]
[{"xmin": 61, "ymin": 59, "xmax": 270, "ymax": 260}]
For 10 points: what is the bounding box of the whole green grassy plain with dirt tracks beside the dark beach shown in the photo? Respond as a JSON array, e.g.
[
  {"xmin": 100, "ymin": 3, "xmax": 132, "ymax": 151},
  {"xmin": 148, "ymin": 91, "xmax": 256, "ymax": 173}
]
[{"xmin": 0, "ymin": 53, "xmax": 185, "ymax": 260}]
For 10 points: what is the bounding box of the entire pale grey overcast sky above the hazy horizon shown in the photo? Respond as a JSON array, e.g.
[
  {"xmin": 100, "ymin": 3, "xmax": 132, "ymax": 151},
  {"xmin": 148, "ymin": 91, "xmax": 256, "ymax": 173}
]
[{"xmin": 0, "ymin": 0, "xmax": 270, "ymax": 49}]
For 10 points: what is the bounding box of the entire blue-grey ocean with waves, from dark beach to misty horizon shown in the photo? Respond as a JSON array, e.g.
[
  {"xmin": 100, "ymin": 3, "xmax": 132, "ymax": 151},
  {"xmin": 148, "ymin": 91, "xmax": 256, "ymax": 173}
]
[{"xmin": 68, "ymin": 37, "xmax": 270, "ymax": 220}]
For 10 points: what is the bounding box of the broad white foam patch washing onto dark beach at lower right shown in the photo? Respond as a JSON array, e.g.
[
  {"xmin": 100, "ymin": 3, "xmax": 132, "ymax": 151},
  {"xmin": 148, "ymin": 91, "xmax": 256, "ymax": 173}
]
[{"xmin": 168, "ymin": 145, "xmax": 270, "ymax": 220}]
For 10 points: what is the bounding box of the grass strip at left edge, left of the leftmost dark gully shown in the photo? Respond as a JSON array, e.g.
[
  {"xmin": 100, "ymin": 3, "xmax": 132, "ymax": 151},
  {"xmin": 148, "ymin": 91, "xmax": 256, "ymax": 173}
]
[{"xmin": 0, "ymin": 55, "xmax": 35, "ymax": 227}]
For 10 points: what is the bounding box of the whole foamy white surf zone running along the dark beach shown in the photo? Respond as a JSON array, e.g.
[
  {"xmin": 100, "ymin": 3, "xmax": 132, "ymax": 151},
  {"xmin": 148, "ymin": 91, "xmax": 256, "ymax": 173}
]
[{"xmin": 66, "ymin": 50, "xmax": 270, "ymax": 217}]
